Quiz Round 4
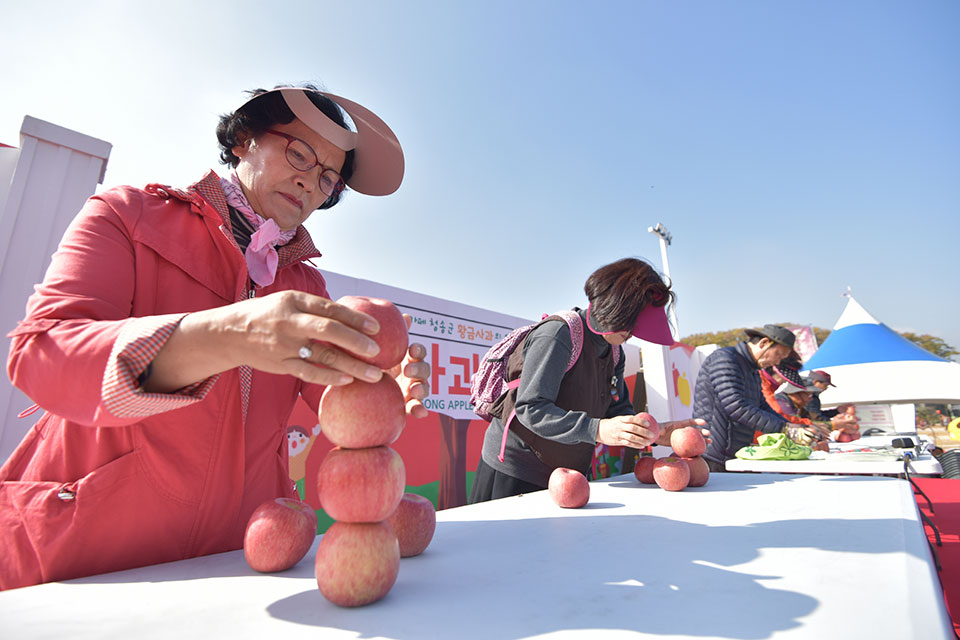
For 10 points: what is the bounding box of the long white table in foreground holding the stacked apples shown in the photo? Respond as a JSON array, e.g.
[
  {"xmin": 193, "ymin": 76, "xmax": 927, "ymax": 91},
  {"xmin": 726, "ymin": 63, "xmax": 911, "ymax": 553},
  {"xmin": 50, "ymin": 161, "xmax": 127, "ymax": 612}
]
[{"xmin": 0, "ymin": 473, "xmax": 954, "ymax": 640}]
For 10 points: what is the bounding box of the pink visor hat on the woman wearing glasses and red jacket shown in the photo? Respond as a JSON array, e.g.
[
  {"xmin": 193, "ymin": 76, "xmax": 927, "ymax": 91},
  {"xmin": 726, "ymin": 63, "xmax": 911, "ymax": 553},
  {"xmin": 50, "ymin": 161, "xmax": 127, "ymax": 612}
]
[{"xmin": 240, "ymin": 87, "xmax": 404, "ymax": 196}]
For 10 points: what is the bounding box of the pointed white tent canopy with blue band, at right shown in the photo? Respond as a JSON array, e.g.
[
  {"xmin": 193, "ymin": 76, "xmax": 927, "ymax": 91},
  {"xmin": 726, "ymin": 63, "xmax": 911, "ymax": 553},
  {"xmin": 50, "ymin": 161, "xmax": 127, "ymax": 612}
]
[{"xmin": 803, "ymin": 297, "xmax": 960, "ymax": 406}]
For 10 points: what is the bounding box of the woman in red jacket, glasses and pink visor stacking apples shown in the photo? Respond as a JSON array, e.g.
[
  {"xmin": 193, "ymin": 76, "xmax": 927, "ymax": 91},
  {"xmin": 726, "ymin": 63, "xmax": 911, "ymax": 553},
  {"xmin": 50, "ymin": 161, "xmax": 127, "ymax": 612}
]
[{"xmin": 0, "ymin": 87, "xmax": 429, "ymax": 589}]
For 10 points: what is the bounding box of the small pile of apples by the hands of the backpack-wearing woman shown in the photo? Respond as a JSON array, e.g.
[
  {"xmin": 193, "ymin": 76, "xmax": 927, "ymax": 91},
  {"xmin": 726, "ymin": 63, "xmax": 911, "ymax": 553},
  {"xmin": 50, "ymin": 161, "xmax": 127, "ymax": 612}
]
[{"xmin": 633, "ymin": 417, "xmax": 710, "ymax": 491}]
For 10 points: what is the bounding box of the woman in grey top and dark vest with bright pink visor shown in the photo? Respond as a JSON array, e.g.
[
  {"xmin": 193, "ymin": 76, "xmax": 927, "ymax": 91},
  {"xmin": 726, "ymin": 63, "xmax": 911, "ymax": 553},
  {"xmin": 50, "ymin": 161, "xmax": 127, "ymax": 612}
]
[{"xmin": 470, "ymin": 258, "xmax": 709, "ymax": 503}]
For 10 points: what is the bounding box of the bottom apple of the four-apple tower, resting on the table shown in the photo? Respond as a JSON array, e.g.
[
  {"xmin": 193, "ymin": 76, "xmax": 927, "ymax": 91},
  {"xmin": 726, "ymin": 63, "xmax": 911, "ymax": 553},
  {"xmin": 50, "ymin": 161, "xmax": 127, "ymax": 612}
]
[{"xmin": 316, "ymin": 522, "xmax": 400, "ymax": 607}]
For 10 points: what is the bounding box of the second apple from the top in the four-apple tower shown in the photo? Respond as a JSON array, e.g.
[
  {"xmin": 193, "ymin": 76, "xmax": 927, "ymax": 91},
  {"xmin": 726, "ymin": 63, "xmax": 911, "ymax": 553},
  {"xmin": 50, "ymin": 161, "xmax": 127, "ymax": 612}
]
[{"xmin": 320, "ymin": 376, "xmax": 407, "ymax": 449}]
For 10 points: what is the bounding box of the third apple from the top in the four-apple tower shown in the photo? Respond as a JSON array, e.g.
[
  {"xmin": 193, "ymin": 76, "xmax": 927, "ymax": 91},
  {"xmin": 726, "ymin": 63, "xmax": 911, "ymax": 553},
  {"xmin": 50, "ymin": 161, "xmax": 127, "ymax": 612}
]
[{"xmin": 317, "ymin": 447, "xmax": 407, "ymax": 522}]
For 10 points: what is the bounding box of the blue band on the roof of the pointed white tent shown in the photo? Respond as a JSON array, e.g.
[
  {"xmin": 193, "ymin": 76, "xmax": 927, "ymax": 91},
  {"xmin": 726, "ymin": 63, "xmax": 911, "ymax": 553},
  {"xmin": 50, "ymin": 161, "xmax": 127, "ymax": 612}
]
[{"xmin": 803, "ymin": 323, "xmax": 946, "ymax": 371}]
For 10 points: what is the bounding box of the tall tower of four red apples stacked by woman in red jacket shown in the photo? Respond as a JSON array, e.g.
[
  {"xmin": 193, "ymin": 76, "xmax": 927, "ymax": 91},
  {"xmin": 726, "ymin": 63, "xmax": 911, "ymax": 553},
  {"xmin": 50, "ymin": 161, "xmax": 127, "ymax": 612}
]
[{"xmin": 316, "ymin": 296, "xmax": 420, "ymax": 607}]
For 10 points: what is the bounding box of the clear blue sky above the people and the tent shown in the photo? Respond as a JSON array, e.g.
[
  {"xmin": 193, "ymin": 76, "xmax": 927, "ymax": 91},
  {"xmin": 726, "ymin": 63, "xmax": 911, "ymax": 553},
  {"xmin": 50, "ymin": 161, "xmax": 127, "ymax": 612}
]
[{"xmin": 0, "ymin": 0, "xmax": 960, "ymax": 356}]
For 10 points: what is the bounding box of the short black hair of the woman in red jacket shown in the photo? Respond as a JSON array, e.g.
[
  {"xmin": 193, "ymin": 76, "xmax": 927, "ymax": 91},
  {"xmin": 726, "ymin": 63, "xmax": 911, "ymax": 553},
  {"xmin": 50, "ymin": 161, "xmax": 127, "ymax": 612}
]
[{"xmin": 217, "ymin": 84, "xmax": 354, "ymax": 209}]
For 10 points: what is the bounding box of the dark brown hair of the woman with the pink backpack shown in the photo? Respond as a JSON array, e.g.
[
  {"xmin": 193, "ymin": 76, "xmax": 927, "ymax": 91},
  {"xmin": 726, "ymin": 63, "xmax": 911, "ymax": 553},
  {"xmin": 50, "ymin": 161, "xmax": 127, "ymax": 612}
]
[{"xmin": 583, "ymin": 258, "xmax": 676, "ymax": 331}]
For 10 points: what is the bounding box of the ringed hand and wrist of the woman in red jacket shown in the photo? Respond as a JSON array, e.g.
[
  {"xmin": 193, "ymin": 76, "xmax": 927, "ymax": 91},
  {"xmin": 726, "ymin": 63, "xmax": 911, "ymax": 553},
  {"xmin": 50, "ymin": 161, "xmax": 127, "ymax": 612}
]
[{"xmin": 145, "ymin": 291, "xmax": 383, "ymax": 392}]
